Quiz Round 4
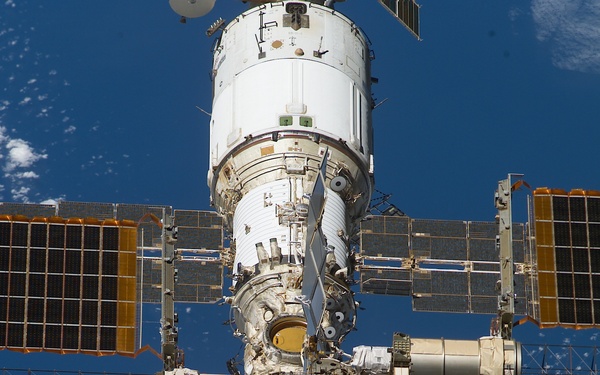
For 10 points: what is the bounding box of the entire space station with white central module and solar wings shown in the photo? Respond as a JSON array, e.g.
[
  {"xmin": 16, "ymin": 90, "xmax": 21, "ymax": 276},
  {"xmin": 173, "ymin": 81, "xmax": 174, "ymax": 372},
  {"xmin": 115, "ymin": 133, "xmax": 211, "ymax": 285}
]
[{"xmin": 0, "ymin": 0, "xmax": 600, "ymax": 375}]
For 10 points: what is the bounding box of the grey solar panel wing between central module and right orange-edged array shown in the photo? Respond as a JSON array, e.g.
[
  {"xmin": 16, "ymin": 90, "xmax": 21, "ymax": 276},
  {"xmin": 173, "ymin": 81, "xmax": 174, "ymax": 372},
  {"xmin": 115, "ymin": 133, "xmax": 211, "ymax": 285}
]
[{"xmin": 360, "ymin": 216, "xmax": 528, "ymax": 314}]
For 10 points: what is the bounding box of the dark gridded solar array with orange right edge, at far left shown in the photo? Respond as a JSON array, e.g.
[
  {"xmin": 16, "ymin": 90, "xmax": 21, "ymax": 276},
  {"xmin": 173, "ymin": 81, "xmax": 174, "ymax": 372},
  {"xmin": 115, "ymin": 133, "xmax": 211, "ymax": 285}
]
[{"xmin": 0, "ymin": 218, "xmax": 136, "ymax": 354}]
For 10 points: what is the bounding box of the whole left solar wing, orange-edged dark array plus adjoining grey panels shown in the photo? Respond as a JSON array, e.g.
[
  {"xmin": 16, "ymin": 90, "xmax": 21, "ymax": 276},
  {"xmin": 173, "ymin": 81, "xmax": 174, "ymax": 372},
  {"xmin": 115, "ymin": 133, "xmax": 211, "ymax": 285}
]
[{"xmin": 0, "ymin": 202, "xmax": 223, "ymax": 356}]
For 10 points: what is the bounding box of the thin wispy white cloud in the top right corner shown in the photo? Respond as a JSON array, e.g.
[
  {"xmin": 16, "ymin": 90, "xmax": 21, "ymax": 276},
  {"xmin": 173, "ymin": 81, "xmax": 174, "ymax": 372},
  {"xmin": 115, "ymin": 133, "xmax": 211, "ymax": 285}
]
[{"xmin": 531, "ymin": 0, "xmax": 600, "ymax": 74}]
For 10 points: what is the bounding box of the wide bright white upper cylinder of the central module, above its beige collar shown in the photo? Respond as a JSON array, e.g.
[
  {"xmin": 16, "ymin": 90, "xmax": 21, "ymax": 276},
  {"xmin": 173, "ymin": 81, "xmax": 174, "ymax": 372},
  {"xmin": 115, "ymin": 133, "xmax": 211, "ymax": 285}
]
[{"xmin": 210, "ymin": 1, "xmax": 371, "ymax": 167}]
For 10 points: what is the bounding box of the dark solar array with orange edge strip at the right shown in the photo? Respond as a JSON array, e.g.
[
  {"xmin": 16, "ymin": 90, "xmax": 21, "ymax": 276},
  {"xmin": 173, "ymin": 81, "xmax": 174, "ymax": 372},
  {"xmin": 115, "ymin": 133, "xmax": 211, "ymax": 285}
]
[{"xmin": 534, "ymin": 188, "xmax": 600, "ymax": 328}]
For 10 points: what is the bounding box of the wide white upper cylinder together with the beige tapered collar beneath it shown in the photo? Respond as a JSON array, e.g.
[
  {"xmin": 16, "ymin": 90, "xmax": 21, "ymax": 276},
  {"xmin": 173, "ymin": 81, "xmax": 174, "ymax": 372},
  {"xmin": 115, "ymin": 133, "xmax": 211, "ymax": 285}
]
[{"xmin": 208, "ymin": 1, "xmax": 372, "ymax": 224}]
